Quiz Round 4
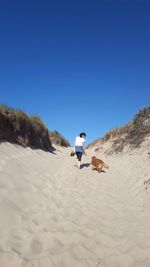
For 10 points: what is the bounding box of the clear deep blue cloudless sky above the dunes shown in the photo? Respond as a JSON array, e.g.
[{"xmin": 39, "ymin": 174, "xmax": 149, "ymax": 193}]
[{"xmin": 0, "ymin": 0, "xmax": 150, "ymax": 145}]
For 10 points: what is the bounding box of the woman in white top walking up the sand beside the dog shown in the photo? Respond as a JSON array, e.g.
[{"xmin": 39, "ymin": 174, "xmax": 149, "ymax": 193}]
[{"xmin": 74, "ymin": 133, "xmax": 86, "ymax": 169}]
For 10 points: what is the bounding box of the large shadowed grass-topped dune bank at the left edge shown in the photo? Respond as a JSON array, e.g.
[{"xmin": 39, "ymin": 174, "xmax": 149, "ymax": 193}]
[{"xmin": 0, "ymin": 105, "xmax": 53, "ymax": 151}]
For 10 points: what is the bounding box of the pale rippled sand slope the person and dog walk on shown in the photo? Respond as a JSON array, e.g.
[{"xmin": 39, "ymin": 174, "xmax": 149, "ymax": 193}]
[{"xmin": 0, "ymin": 143, "xmax": 150, "ymax": 267}]
